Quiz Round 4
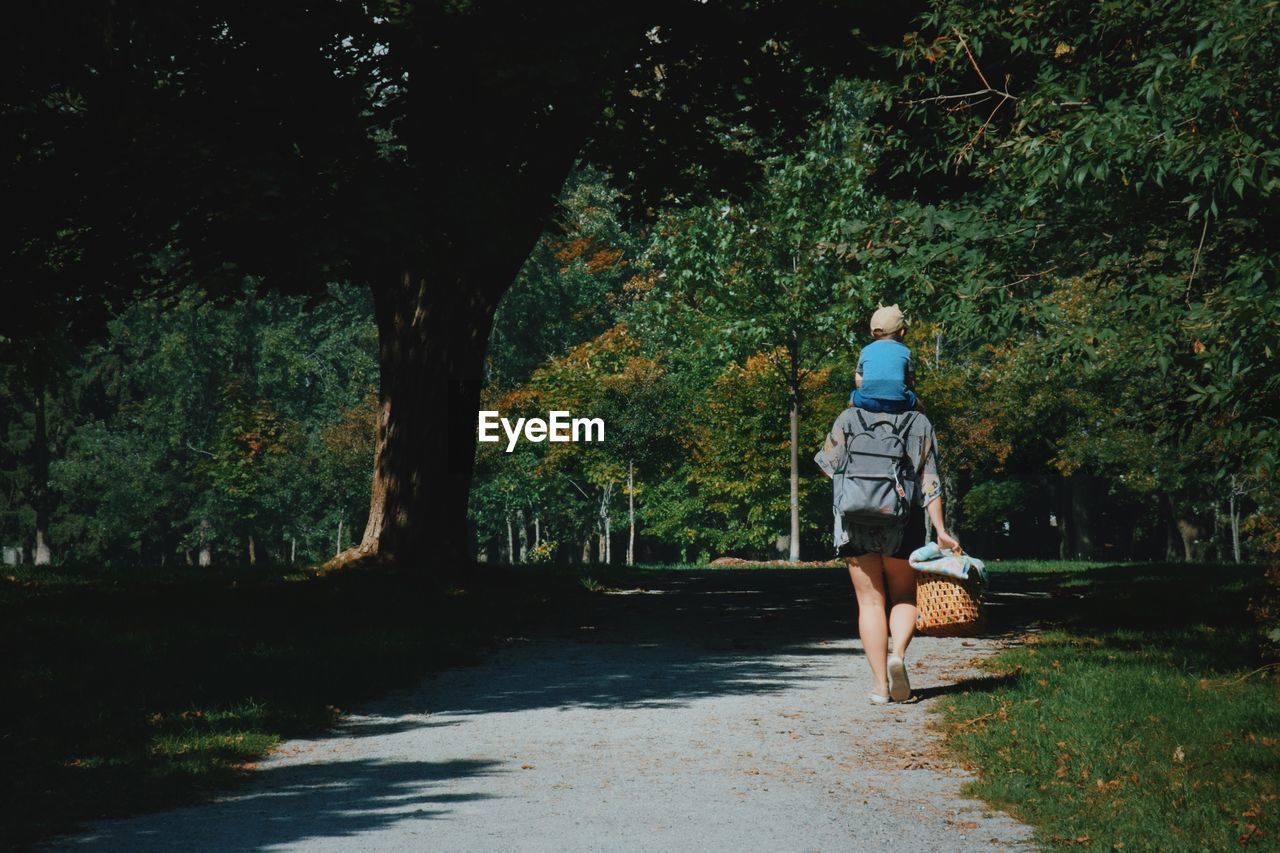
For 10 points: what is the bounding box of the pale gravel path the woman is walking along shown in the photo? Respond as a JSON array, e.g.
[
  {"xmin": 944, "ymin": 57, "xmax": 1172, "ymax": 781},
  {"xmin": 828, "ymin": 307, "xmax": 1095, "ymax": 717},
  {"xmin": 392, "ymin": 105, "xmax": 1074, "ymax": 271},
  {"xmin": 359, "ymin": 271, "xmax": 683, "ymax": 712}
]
[{"xmin": 58, "ymin": 569, "xmax": 1030, "ymax": 853}]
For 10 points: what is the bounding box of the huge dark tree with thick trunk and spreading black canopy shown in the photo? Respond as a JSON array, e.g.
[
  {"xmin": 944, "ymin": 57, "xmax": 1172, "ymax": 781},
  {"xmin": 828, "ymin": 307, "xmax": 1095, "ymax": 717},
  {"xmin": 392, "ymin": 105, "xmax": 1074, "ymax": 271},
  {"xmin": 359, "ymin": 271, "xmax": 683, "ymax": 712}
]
[{"xmin": 0, "ymin": 0, "xmax": 926, "ymax": 564}]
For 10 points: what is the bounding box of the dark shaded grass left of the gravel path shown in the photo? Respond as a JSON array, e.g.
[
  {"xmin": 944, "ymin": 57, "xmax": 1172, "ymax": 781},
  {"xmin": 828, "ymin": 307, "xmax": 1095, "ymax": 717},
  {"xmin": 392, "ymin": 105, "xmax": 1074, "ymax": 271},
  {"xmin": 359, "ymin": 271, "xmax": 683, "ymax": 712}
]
[{"xmin": 0, "ymin": 567, "xmax": 585, "ymax": 847}]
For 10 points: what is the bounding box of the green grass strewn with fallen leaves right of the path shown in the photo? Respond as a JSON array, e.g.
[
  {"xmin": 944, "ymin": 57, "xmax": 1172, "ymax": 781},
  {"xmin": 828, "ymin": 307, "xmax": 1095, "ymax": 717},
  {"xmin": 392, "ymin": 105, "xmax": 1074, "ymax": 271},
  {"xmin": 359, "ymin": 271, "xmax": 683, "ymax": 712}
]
[{"xmin": 942, "ymin": 564, "xmax": 1280, "ymax": 850}]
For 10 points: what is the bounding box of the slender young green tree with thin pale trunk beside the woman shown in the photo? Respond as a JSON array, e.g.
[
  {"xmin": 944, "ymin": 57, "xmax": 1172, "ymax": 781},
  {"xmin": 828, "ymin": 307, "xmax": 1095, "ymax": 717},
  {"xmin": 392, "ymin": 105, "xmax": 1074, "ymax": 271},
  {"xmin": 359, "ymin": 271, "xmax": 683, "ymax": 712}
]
[{"xmin": 650, "ymin": 79, "xmax": 874, "ymax": 561}]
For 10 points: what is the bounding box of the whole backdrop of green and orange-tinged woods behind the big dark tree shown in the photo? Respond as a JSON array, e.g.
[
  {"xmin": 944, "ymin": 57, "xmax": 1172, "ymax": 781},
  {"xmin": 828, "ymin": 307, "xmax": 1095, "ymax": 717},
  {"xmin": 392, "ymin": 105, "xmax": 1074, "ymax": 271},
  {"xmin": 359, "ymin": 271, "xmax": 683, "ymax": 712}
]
[{"xmin": 0, "ymin": 3, "xmax": 1280, "ymax": 566}]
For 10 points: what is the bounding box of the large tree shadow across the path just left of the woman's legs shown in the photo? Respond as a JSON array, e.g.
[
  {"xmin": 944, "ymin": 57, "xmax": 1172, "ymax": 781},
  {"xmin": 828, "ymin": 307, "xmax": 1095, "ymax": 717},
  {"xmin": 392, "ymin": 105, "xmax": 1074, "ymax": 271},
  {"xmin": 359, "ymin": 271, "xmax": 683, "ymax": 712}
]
[{"xmin": 392, "ymin": 569, "xmax": 858, "ymax": 715}]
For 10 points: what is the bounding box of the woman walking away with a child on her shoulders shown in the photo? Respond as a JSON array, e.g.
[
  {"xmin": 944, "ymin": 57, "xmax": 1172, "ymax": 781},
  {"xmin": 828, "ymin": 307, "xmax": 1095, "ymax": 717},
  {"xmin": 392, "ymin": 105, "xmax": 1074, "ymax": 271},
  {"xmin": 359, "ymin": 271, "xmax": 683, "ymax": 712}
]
[{"xmin": 814, "ymin": 407, "xmax": 960, "ymax": 704}]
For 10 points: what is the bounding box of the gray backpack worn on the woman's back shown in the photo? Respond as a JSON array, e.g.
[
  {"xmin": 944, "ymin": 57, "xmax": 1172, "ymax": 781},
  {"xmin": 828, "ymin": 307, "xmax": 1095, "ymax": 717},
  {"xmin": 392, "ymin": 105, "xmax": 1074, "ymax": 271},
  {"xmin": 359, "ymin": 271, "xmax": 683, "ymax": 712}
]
[{"xmin": 832, "ymin": 409, "xmax": 916, "ymax": 526}]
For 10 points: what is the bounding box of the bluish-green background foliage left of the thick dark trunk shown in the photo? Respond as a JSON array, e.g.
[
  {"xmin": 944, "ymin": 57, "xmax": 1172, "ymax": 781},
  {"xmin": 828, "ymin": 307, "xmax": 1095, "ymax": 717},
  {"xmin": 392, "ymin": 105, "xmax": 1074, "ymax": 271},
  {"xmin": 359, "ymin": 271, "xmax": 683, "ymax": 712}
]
[{"xmin": 4, "ymin": 281, "xmax": 378, "ymax": 565}]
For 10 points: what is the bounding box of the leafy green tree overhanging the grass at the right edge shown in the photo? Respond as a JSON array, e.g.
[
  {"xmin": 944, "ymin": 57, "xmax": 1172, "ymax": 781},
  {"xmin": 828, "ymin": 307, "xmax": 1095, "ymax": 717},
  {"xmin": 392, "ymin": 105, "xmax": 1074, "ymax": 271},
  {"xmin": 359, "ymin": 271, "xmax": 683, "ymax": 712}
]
[{"xmin": 829, "ymin": 1, "xmax": 1280, "ymax": 556}]
